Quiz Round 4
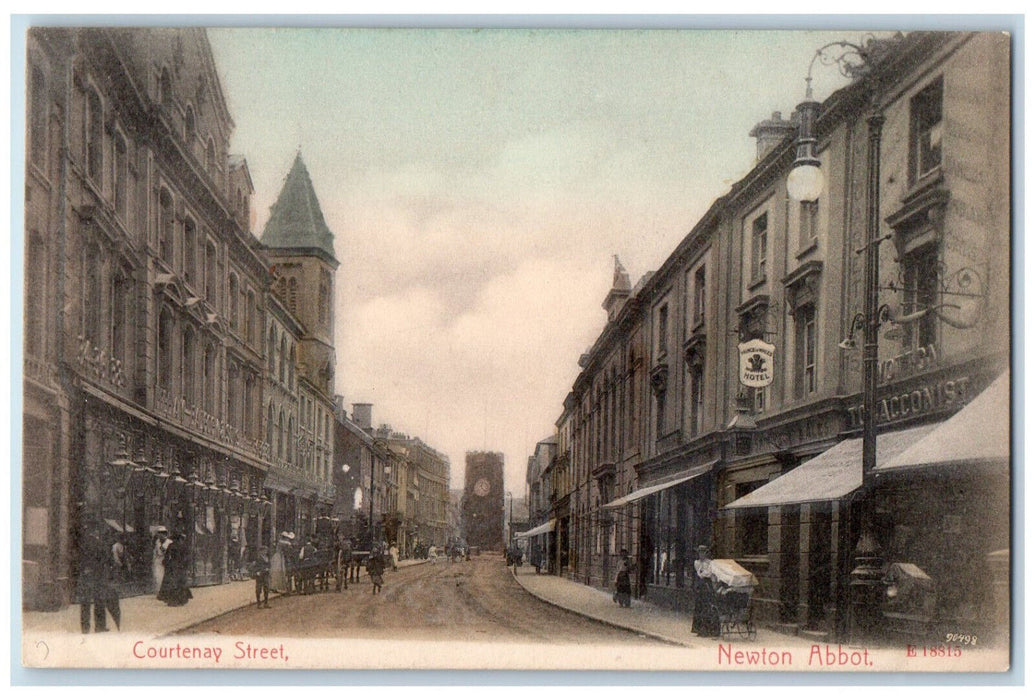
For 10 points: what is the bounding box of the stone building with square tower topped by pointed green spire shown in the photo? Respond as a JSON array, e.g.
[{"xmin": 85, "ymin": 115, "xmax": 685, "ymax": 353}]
[{"xmin": 261, "ymin": 153, "xmax": 338, "ymax": 534}]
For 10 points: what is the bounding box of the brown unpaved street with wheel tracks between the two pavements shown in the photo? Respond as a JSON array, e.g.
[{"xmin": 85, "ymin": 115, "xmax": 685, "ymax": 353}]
[{"xmin": 185, "ymin": 555, "xmax": 661, "ymax": 645}]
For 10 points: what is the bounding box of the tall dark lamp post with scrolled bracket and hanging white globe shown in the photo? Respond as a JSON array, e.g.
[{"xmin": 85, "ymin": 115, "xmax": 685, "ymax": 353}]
[{"xmin": 788, "ymin": 39, "xmax": 889, "ymax": 633}]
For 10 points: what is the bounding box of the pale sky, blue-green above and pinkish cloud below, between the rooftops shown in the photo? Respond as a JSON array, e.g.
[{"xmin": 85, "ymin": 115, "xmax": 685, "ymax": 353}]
[{"xmin": 208, "ymin": 28, "xmax": 863, "ymax": 498}]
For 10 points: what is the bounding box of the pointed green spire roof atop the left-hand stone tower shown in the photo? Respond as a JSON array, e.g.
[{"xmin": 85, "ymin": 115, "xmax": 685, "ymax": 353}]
[{"xmin": 261, "ymin": 152, "xmax": 336, "ymax": 260}]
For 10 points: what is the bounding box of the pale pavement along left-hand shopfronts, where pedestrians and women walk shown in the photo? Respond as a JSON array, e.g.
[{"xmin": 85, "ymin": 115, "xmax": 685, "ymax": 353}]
[{"xmin": 22, "ymin": 559, "xmax": 424, "ymax": 637}]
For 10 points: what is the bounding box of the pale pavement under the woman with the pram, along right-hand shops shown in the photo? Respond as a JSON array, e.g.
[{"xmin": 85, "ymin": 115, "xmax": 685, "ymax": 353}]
[{"xmin": 514, "ymin": 566, "xmax": 802, "ymax": 647}]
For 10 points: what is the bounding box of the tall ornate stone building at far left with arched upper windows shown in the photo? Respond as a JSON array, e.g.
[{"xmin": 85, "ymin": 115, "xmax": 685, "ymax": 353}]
[{"xmin": 22, "ymin": 28, "xmax": 332, "ymax": 608}]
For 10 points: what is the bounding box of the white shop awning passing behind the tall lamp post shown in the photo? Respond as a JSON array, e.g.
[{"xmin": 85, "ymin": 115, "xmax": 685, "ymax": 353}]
[{"xmin": 726, "ymin": 426, "xmax": 937, "ymax": 508}]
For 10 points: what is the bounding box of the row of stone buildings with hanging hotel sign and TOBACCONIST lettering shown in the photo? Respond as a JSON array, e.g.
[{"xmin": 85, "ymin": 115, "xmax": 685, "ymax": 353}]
[{"xmin": 550, "ymin": 32, "xmax": 1010, "ymax": 636}]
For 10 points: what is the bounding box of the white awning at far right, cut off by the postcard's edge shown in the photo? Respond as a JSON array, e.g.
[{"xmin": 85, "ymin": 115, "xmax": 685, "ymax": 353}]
[{"xmin": 877, "ymin": 372, "xmax": 1010, "ymax": 472}]
